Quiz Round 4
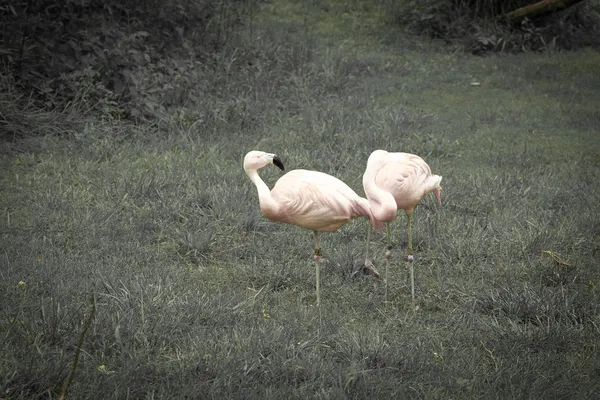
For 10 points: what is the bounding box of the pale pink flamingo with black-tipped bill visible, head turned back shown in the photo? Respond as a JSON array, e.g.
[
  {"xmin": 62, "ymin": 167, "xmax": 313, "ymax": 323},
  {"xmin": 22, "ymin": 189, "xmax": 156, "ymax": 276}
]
[{"xmin": 244, "ymin": 150, "xmax": 383, "ymax": 305}]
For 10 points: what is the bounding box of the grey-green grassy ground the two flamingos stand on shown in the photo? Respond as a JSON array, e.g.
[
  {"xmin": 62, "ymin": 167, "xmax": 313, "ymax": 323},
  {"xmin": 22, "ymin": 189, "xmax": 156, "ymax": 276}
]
[{"xmin": 0, "ymin": 1, "xmax": 600, "ymax": 399}]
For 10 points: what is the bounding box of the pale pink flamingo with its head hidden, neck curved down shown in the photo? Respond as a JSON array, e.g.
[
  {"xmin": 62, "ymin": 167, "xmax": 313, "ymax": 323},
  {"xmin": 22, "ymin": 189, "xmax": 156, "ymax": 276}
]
[{"xmin": 363, "ymin": 150, "xmax": 442, "ymax": 304}]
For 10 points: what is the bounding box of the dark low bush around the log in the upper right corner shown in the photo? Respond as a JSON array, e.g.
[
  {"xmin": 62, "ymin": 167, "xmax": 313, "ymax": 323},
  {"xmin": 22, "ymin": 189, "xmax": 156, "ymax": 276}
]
[{"xmin": 394, "ymin": 0, "xmax": 600, "ymax": 54}]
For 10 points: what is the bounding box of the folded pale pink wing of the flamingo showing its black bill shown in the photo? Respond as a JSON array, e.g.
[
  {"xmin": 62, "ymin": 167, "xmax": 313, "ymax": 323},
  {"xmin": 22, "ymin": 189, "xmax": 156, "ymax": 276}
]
[{"xmin": 271, "ymin": 169, "xmax": 374, "ymax": 232}]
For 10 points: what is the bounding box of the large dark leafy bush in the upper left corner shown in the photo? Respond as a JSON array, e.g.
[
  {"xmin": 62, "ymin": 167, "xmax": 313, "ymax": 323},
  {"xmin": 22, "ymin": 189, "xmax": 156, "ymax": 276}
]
[{"xmin": 0, "ymin": 0, "xmax": 255, "ymax": 123}]
